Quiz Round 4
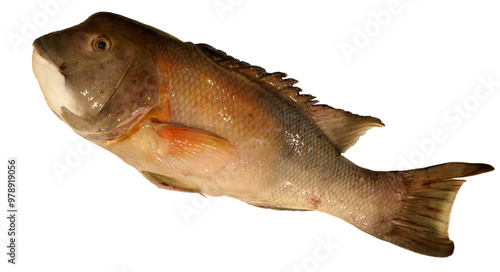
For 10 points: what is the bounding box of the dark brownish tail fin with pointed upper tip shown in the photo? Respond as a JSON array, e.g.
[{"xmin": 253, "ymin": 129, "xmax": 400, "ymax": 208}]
[{"xmin": 381, "ymin": 163, "xmax": 494, "ymax": 257}]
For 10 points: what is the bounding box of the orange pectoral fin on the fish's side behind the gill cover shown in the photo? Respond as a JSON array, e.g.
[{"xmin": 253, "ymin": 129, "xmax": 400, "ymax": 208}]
[{"xmin": 152, "ymin": 122, "xmax": 236, "ymax": 174}]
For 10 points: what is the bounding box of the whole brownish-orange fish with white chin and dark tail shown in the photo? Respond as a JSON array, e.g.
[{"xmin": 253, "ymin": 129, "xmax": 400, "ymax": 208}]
[{"xmin": 32, "ymin": 12, "xmax": 494, "ymax": 257}]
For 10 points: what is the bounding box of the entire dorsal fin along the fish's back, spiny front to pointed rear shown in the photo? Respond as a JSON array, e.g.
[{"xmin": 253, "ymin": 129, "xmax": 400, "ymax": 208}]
[{"xmin": 196, "ymin": 44, "xmax": 384, "ymax": 153}]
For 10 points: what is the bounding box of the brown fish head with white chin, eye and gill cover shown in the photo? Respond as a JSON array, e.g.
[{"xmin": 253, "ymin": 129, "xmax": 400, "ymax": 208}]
[{"xmin": 32, "ymin": 12, "xmax": 164, "ymax": 141}]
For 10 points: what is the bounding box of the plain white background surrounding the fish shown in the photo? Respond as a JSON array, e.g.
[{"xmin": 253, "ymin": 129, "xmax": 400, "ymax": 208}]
[{"xmin": 0, "ymin": 0, "xmax": 500, "ymax": 272}]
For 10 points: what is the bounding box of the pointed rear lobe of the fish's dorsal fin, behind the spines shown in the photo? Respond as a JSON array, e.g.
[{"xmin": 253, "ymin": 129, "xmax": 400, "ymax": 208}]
[{"xmin": 311, "ymin": 105, "xmax": 384, "ymax": 153}]
